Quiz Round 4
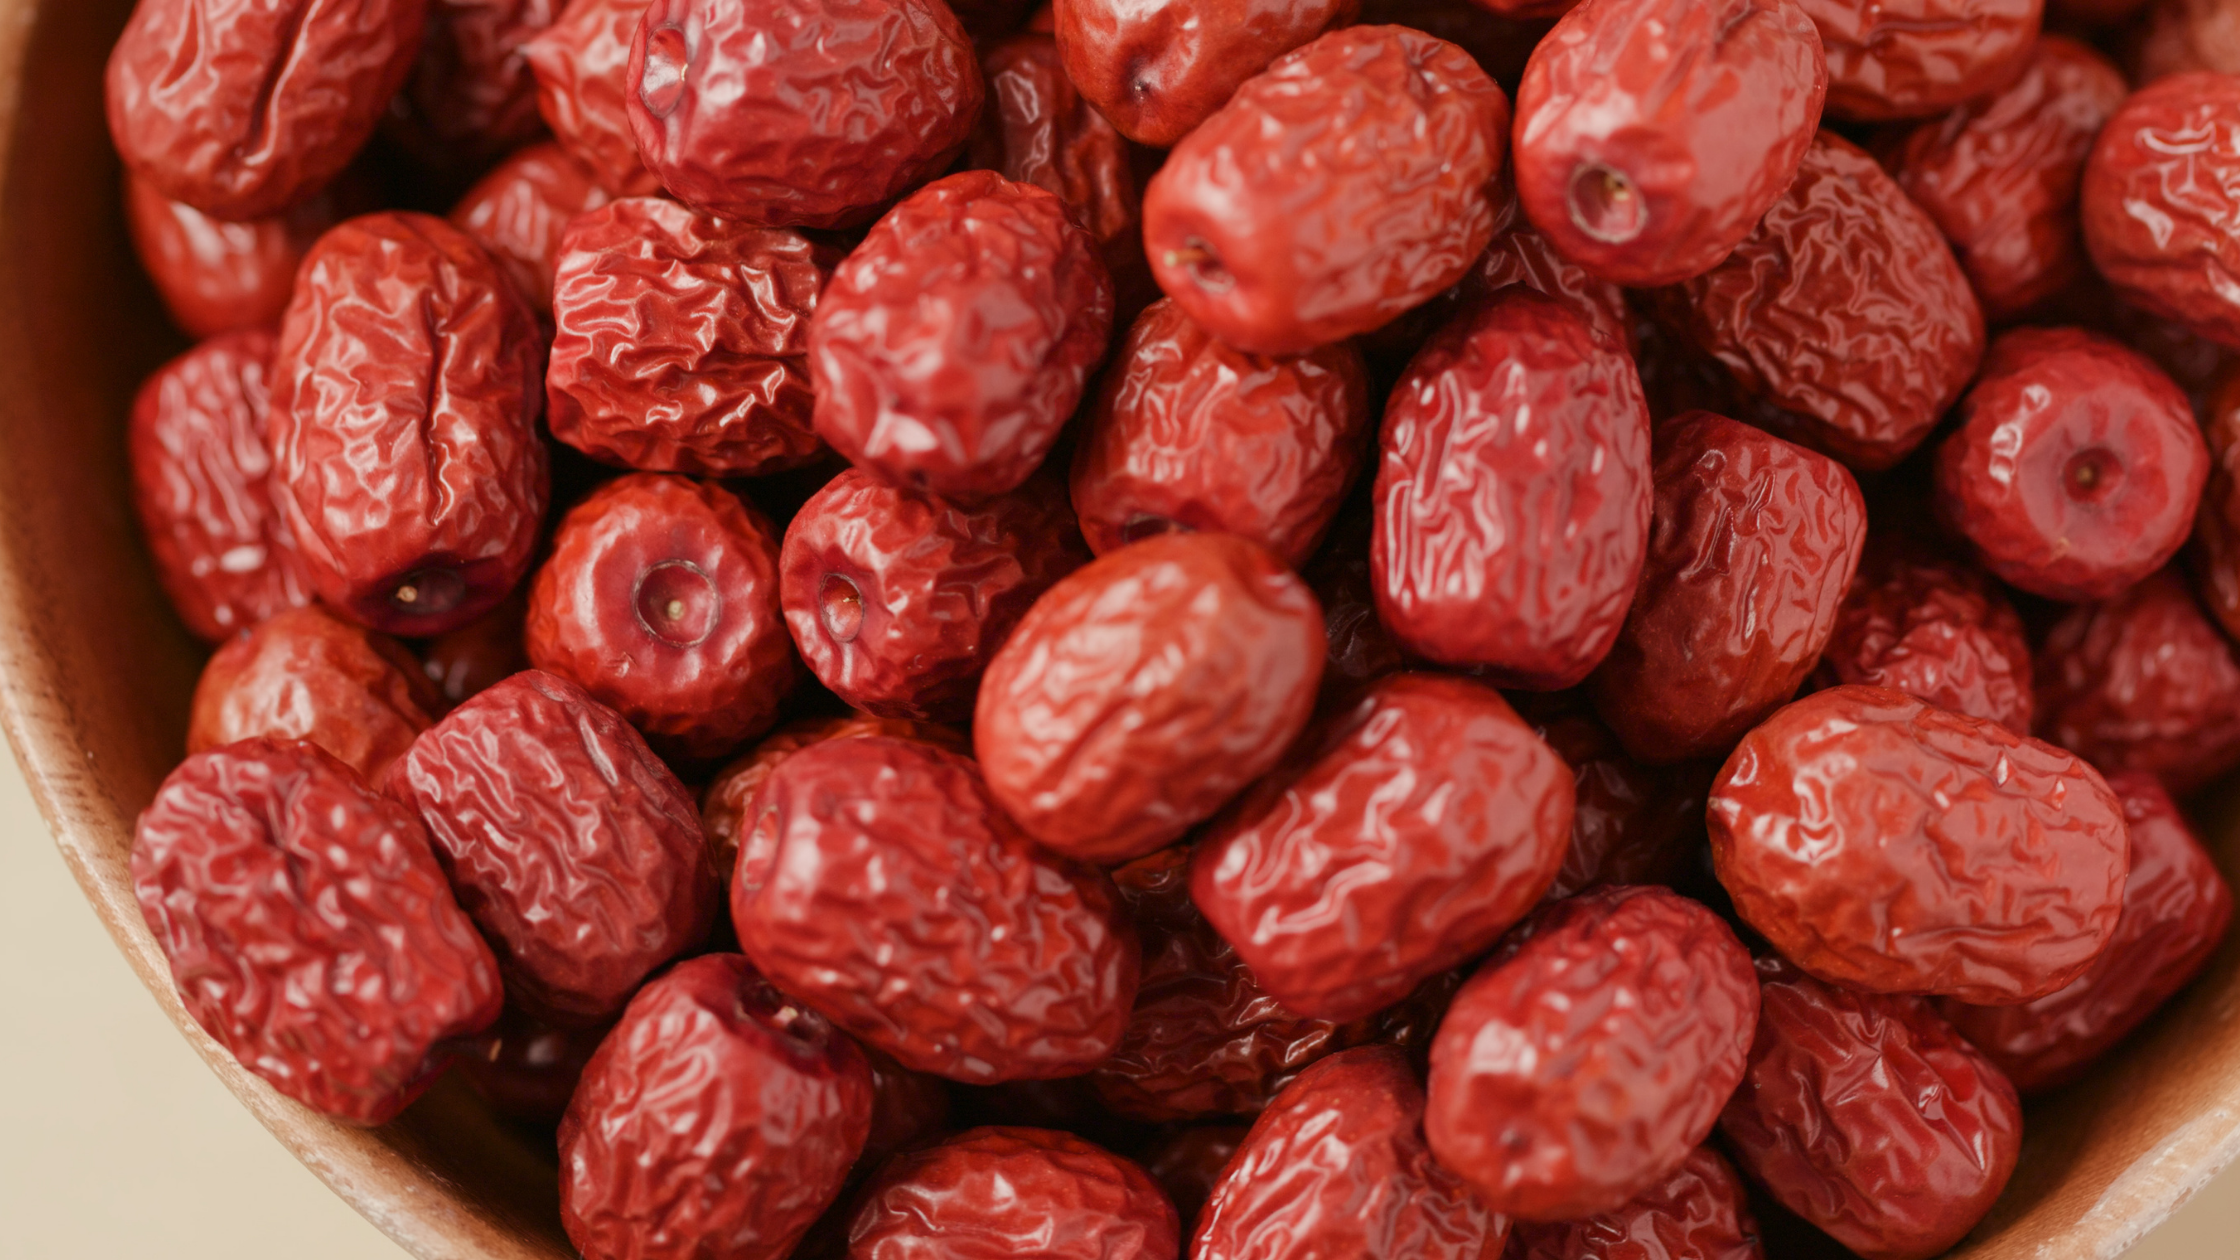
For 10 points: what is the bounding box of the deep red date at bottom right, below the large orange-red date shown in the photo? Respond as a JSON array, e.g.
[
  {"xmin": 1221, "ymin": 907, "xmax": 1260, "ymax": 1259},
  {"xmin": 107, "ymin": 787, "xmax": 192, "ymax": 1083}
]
[{"xmin": 1718, "ymin": 960, "xmax": 2023, "ymax": 1260}]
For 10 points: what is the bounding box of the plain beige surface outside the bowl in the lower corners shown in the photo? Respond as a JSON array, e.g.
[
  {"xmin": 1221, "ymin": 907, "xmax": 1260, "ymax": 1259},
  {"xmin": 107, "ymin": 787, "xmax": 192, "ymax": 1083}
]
[{"xmin": 0, "ymin": 739, "xmax": 2240, "ymax": 1260}]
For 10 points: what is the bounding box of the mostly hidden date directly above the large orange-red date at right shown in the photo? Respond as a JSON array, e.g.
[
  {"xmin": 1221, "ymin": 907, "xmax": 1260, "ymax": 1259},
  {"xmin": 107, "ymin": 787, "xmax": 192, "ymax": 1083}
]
[{"xmin": 1814, "ymin": 545, "xmax": 2034, "ymax": 735}]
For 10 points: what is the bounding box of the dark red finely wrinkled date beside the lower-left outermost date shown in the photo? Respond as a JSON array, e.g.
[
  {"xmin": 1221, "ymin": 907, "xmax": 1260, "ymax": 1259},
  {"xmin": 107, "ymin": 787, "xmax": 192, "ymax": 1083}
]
[{"xmin": 388, "ymin": 670, "xmax": 721, "ymax": 1027}]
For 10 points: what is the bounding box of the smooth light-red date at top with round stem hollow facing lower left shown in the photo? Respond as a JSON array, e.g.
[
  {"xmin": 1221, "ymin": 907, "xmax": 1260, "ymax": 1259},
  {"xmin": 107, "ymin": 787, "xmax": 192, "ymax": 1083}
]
[{"xmin": 1516, "ymin": 0, "xmax": 1828, "ymax": 287}]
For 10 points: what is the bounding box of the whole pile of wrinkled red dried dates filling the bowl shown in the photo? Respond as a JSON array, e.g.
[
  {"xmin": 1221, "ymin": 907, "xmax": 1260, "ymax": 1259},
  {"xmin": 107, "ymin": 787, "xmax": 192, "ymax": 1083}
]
[{"xmin": 108, "ymin": 0, "xmax": 2240, "ymax": 1260}]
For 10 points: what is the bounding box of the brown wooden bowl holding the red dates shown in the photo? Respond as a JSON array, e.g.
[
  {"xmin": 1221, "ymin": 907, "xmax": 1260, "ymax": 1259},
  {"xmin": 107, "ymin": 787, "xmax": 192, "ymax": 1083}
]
[{"xmin": 0, "ymin": 0, "xmax": 2240, "ymax": 1260}]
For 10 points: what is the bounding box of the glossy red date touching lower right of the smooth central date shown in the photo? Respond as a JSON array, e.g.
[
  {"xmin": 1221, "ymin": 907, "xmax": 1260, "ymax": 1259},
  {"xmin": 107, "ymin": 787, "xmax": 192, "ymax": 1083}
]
[{"xmin": 1189, "ymin": 673, "xmax": 1572, "ymax": 1020}]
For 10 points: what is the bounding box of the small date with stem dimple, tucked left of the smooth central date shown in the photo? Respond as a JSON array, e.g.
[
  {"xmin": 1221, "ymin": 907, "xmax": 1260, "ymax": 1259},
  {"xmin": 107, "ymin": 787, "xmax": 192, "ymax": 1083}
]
[{"xmin": 777, "ymin": 469, "xmax": 1089, "ymax": 722}]
